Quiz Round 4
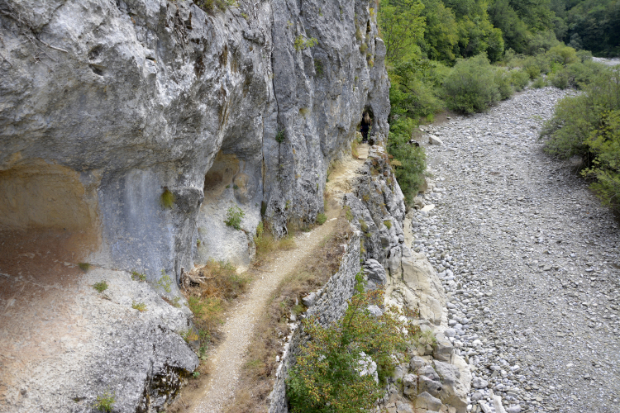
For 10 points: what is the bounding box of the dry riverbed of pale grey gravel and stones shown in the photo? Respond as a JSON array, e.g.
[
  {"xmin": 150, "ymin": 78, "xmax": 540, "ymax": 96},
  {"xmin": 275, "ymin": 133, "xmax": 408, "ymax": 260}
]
[{"xmin": 412, "ymin": 88, "xmax": 620, "ymax": 413}]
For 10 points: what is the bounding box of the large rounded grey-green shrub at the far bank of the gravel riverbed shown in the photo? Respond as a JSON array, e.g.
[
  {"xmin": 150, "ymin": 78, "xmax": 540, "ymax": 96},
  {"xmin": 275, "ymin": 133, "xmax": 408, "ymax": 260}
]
[{"xmin": 444, "ymin": 54, "xmax": 501, "ymax": 114}]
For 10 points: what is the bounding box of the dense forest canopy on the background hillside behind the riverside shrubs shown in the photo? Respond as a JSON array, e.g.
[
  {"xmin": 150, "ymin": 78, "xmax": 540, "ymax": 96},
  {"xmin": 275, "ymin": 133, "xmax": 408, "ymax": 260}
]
[{"xmin": 379, "ymin": 0, "xmax": 620, "ymax": 65}]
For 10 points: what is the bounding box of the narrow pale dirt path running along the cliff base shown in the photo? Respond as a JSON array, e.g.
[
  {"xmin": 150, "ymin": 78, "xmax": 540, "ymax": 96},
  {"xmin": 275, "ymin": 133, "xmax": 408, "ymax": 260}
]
[{"xmin": 190, "ymin": 145, "xmax": 368, "ymax": 413}]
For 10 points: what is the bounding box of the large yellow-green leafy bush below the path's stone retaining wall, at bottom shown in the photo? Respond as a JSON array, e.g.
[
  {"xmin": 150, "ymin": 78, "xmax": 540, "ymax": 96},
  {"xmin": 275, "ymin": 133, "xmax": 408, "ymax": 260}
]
[{"xmin": 287, "ymin": 284, "xmax": 413, "ymax": 413}]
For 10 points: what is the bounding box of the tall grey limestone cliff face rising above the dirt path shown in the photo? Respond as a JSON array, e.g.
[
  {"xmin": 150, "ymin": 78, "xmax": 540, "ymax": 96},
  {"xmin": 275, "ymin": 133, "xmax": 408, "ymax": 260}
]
[{"xmin": 0, "ymin": 0, "xmax": 389, "ymax": 280}]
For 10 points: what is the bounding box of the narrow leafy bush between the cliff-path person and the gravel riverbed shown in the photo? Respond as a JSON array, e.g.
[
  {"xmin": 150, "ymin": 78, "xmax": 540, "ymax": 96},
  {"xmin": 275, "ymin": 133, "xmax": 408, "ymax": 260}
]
[{"xmin": 387, "ymin": 118, "xmax": 426, "ymax": 204}]
